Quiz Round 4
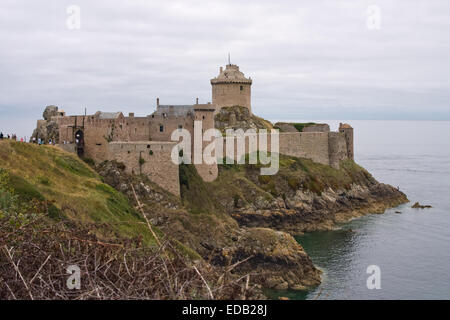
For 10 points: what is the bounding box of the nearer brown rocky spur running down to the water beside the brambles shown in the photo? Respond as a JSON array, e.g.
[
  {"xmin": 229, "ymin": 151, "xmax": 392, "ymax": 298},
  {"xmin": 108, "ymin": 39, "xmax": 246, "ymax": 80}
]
[{"xmin": 96, "ymin": 162, "xmax": 321, "ymax": 290}]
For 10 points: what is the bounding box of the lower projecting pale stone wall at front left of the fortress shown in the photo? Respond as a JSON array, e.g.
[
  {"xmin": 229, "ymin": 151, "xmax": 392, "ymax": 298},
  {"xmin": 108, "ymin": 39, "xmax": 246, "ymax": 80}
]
[{"xmin": 106, "ymin": 141, "xmax": 180, "ymax": 196}]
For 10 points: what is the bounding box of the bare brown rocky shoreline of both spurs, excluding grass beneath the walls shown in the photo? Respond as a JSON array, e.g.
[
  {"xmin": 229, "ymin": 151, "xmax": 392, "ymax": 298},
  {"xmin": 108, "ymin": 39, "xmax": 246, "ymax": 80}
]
[{"xmin": 97, "ymin": 162, "xmax": 408, "ymax": 290}]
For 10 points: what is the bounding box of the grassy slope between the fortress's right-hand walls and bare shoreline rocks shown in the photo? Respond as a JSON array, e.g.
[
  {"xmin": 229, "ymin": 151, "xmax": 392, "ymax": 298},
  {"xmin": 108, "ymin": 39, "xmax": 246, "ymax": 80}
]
[{"xmin": 180, "ymin": 155, "xmax": 375, "ymax": 212}]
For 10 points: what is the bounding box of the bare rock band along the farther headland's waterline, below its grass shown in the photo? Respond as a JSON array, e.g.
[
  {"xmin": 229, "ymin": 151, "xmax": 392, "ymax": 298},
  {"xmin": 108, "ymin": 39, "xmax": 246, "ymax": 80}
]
[{"xmin": 230, "ymin": 183, "xmax": 408, "ymax": 234}]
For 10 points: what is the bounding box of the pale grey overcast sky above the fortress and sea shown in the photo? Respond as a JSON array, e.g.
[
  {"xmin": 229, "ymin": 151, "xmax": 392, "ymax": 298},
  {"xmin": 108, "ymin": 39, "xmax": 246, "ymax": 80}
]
[{"xmin": 0, "ymin": 0, "xmax": 450, "ymax": 135}]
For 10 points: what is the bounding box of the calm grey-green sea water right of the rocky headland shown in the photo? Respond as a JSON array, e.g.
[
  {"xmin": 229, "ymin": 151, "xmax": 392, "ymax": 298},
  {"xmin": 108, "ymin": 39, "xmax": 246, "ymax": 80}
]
[{"xmin": 270, "ymin": 120, "xmax": 450, "ymax": 299}]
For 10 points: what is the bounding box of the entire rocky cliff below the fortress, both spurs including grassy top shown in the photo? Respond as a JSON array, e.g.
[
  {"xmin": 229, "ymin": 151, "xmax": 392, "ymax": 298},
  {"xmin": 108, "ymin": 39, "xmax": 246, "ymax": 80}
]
[{"xmin": 98, "ymin": 150, "xmax": 407, "ymax": 289}]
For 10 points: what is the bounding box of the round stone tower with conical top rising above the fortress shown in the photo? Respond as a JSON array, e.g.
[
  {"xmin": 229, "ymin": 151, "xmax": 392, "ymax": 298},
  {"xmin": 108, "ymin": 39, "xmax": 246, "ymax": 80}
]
[{"xmin": 211, "ymin": 64, "xmax": 252, "ymax": 114}]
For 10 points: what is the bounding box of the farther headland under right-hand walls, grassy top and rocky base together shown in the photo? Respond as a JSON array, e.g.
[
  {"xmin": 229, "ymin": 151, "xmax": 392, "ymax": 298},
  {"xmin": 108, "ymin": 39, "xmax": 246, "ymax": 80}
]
[{"xmin": 199, "ymin": 156, "xmax": 408, "ymax": 235}]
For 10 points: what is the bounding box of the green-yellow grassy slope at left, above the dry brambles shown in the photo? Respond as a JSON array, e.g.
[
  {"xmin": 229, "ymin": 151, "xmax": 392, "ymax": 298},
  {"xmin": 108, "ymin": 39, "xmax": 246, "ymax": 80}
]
[{"xmin": 0, "ymin": 141, "xmax": 158, "ymax": 244}]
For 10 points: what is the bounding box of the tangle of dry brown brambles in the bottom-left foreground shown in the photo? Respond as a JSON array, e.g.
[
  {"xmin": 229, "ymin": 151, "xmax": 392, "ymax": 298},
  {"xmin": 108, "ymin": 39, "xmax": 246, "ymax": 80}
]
[{"xmin": 0, "ymin": 216, "xmax": 256, "ymax": 300}]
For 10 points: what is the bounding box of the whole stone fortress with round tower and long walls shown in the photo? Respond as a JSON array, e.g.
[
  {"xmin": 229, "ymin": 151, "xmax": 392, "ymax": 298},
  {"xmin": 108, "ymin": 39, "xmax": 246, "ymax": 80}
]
[{"xmin": 32, "ymin": 64, "xmax": 353, "ymax": 195}]
